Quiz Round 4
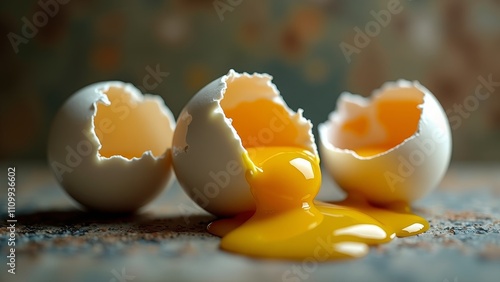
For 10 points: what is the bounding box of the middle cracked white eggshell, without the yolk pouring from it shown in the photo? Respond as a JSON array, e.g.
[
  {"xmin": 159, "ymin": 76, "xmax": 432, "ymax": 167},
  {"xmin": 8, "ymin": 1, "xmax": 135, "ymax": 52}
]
[{"xmin": 172, "ymin": 70, "xmax": 317, "ymax": 216}]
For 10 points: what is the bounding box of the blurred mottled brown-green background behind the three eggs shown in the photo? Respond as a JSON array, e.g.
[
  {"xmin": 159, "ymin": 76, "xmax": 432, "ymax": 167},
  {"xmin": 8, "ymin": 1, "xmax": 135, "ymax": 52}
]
[{"xmin": 0, "ymin": 0, "xmax": 500, "ymax": 161}]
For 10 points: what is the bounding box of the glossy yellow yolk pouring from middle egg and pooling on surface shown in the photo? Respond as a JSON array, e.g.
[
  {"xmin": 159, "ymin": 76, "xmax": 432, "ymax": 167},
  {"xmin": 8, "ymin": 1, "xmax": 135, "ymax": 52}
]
[{"xmin": 208, "ymin": 97, "xmax": 429, "ymax": 260}]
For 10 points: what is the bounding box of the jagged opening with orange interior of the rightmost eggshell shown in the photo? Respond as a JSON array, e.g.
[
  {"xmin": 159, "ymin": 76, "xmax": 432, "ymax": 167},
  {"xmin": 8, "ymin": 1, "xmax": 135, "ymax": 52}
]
[{"xmin": 323, "ymin": 81, "xmax": 424, "ymax": 158}]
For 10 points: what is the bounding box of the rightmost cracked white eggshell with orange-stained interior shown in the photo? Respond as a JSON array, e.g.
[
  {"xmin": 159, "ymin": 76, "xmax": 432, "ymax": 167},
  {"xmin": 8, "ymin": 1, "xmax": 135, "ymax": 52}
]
[{"xmin": 318, "ymin": 80, "xmax": 452, "ymax": 204}]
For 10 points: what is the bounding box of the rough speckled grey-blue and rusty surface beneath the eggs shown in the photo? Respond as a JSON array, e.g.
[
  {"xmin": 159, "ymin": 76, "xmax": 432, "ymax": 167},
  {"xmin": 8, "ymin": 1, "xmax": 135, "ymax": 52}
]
[{"xmin": 0, "ymin": 163, "xmax": 500, "ymax": 282}]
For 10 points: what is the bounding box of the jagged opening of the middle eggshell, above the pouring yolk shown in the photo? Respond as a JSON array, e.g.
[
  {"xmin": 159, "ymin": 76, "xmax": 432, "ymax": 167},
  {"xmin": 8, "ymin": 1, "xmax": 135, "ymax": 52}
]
[{"xmin": 218, "ymin": 70, "xmax": 317, "ymax": 154}]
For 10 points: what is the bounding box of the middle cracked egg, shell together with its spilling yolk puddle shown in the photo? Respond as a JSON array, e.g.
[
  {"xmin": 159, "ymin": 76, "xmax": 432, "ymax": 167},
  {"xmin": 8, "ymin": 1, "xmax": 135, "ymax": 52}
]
[{"xmin": 172, "ymin": 70, "xmax": 449, "ymax": 260}]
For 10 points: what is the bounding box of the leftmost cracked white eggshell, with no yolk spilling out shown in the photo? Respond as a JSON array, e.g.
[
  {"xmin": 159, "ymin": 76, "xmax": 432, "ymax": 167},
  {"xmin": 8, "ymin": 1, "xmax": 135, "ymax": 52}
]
[{"xmin": 48, "ymin": 81, "xmax": 175, "ymax": 212}]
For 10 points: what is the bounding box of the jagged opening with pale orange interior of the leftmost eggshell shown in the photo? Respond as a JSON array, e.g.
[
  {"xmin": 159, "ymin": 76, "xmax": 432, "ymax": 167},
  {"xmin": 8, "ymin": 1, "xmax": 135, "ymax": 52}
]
[{"xmin": 93, "ymin": 86, "xmax": 174, "ymax": 159}]
